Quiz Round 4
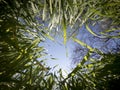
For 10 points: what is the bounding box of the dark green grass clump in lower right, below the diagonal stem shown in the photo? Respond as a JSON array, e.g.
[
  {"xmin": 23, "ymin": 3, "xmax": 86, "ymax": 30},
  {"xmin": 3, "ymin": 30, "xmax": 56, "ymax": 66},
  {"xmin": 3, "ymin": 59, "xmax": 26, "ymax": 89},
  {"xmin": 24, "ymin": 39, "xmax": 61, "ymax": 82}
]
[{"xmin": 61, "ymin": 54, "xmax": 120, "ymax": 90}]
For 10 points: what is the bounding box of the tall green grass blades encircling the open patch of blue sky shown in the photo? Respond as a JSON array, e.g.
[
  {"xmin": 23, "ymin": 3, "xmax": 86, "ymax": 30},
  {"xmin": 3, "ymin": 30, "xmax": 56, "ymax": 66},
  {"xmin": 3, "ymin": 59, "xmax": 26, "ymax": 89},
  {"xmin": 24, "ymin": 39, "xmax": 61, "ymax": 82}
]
[{"xmin": 0, "ymin": 0, "xmax": 120, "ymax": 90}]
